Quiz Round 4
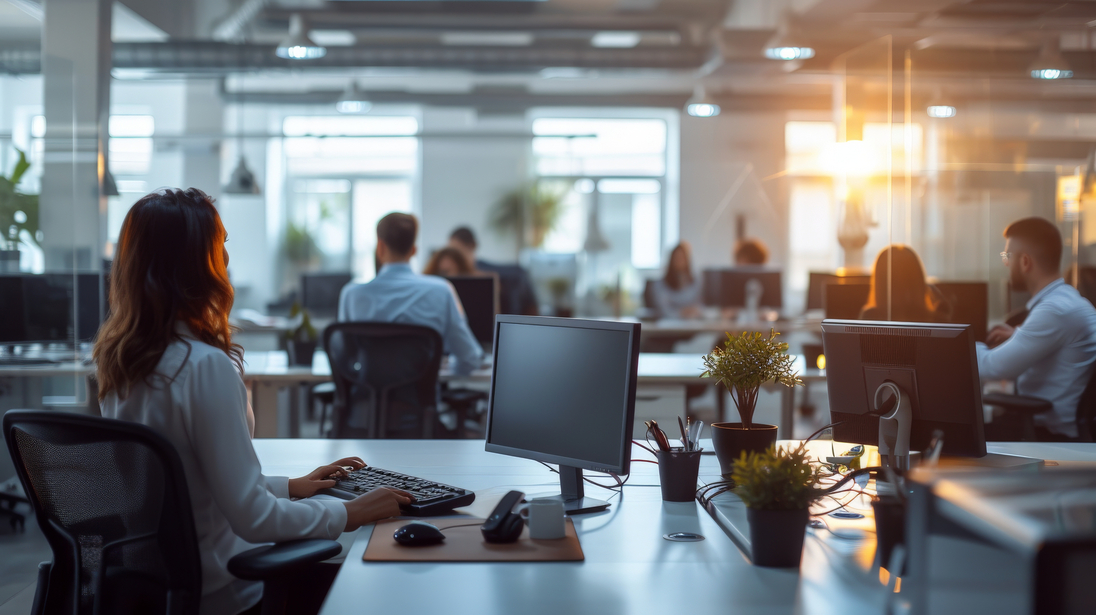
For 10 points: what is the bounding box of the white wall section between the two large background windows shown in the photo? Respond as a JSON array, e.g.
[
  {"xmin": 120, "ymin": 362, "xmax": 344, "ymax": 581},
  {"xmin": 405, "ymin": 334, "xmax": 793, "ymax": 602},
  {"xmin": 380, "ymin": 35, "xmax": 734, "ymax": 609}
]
[{"xmin": 419, "ymin": 107, "xmax": 529, "ymax": 262}]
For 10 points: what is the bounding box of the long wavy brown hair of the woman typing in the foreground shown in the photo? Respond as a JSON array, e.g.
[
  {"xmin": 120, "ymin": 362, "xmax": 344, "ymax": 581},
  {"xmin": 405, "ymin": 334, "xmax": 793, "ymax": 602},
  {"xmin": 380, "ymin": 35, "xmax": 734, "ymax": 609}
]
[{"xmin": 93, "ymin": 187, "xmax": 243, "ymax": 400}]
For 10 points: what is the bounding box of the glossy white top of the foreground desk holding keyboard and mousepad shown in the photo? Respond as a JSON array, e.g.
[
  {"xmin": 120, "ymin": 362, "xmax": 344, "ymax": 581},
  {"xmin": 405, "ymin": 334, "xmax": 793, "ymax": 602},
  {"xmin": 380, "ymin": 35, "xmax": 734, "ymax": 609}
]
[{"xmin": 254, "ymin": 440, "xmax": 1096, "ymax": 615}]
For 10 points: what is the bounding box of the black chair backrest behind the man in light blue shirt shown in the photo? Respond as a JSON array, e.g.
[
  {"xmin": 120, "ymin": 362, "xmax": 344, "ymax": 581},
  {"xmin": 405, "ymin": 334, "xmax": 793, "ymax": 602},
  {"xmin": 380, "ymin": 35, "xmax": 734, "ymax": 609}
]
[{"xmin": 323, "ymin": 322, "xmax": 444, "ymax": 437}]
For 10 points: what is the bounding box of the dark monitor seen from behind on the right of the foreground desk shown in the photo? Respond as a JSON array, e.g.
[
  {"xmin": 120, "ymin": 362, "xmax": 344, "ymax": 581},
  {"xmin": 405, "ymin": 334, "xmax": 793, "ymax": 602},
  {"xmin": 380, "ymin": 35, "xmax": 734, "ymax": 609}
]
[{"xmin": 822, "ymin": 320, "xmax": 985, "ymax": 457}]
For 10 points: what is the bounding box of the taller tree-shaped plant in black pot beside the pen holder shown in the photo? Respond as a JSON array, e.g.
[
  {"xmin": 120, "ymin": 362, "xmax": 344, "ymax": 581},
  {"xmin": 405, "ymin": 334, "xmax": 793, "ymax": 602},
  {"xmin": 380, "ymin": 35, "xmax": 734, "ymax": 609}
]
[{"xmin": 700, "ymin": 329, "xmax": 803, "ymax": 477}]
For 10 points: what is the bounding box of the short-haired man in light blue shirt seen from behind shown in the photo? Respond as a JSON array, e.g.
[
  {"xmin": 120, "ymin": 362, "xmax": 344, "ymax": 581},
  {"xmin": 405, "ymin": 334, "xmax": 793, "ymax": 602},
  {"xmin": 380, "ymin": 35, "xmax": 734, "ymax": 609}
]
[{"xmin": 339, "ymin": 214, "xmax": 483, "ymax": 375}]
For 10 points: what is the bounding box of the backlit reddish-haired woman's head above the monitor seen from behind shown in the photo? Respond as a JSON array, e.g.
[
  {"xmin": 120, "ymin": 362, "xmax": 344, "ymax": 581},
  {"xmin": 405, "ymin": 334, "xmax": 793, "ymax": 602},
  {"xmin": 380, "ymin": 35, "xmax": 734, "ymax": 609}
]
[{"xmin": 860, "ymin": 243, "xmax": 950, "ymax": 322}]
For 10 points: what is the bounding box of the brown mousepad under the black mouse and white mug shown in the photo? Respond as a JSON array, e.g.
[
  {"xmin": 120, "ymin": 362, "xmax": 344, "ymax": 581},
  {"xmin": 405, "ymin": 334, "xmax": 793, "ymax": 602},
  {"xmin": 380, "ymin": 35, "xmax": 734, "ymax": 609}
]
[{"xmin": 362, "ymin": 516, "xmax": 585, "ymax": 561}]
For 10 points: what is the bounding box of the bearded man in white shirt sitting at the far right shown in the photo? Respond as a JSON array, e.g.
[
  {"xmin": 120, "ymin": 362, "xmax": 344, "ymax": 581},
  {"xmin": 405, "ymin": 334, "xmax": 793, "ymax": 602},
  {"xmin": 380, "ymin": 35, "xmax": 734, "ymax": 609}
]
[{"xmin": 977, "ymin": 218, "xmax": 1096, "ymax": 440}]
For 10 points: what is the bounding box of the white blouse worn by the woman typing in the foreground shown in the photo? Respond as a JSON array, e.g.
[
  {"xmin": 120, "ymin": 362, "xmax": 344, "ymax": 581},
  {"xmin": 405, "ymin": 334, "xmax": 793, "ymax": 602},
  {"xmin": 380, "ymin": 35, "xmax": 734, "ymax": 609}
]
[{"xmin": 101, "ymin": 333, "xmax": 346, "ymax": 615}]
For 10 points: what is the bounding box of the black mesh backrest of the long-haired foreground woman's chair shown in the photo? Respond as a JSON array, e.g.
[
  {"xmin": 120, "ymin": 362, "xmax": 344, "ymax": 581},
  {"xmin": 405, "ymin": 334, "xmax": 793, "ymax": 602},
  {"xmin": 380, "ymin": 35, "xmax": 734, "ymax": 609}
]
[{"xmin": 3, "ymin": 410, "xmax": 202, "ymax": 614}]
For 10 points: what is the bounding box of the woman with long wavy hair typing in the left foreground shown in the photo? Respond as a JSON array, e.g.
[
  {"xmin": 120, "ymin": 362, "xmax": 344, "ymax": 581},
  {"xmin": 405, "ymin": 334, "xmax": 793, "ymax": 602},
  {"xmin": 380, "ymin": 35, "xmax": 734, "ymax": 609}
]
[{"xmin": 94, "ymin": 189, "xmax": 410, "ymax": 614}]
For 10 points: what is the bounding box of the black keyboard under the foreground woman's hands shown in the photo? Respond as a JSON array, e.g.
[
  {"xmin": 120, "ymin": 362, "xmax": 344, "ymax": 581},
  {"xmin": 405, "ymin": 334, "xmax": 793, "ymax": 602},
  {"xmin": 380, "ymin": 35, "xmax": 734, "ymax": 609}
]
[{"xmin": 320, "ymin": 466, "xmax": 476, "ymax": 516}]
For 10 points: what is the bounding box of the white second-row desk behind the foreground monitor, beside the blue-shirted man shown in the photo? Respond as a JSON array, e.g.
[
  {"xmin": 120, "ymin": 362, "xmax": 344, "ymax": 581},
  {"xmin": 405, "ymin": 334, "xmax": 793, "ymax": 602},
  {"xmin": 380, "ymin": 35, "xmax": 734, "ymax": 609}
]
[{"xmin": 243, "ymin": 351, "xmax": 825, "ymax": 437}]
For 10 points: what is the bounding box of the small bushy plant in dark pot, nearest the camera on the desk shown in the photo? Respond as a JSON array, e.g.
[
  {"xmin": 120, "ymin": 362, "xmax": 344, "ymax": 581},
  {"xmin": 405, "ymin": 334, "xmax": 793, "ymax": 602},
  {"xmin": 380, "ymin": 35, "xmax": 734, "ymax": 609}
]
[{"xmin": 731, "ymin": 442, "xmax": 824, "ymax": 568}]
